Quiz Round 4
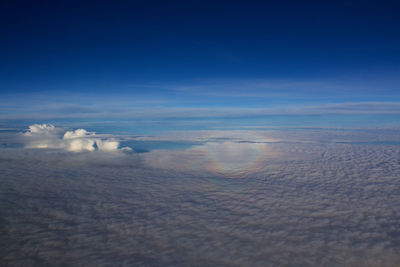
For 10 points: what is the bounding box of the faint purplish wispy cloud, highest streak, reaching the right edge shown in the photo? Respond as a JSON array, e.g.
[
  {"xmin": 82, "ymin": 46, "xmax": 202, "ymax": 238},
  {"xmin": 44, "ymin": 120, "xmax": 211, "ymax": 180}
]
[{"xmin": 127, "ymin": 76, "xmax": 400, "ymax": 99}]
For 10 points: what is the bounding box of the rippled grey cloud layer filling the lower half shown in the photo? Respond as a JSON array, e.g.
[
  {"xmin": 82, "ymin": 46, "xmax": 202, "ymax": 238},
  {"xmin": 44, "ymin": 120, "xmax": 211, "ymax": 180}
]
[{"xmin": 0, "ymin": 137, "xmax": 400, "ymax": 266}]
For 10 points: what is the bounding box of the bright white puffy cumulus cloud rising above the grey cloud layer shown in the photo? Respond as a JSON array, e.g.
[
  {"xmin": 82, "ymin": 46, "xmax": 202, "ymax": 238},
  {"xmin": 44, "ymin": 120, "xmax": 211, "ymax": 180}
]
[{"xmin": 24, "ymin": 124, "xmax": 131, "ymax": 152}]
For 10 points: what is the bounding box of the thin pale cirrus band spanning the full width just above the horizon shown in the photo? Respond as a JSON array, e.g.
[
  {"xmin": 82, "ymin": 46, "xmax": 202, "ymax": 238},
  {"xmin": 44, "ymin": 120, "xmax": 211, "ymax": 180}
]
[{"xmin": 0, "ymin": 101, "xmax": 400, "ymax": 121}]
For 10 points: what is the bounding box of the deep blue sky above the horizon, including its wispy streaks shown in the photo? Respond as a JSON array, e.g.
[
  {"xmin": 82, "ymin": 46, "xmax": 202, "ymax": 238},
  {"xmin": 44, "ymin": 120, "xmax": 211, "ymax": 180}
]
[{"xmin": 0, "ymin": 1, "xmax": 400, "ymax": 131}]
